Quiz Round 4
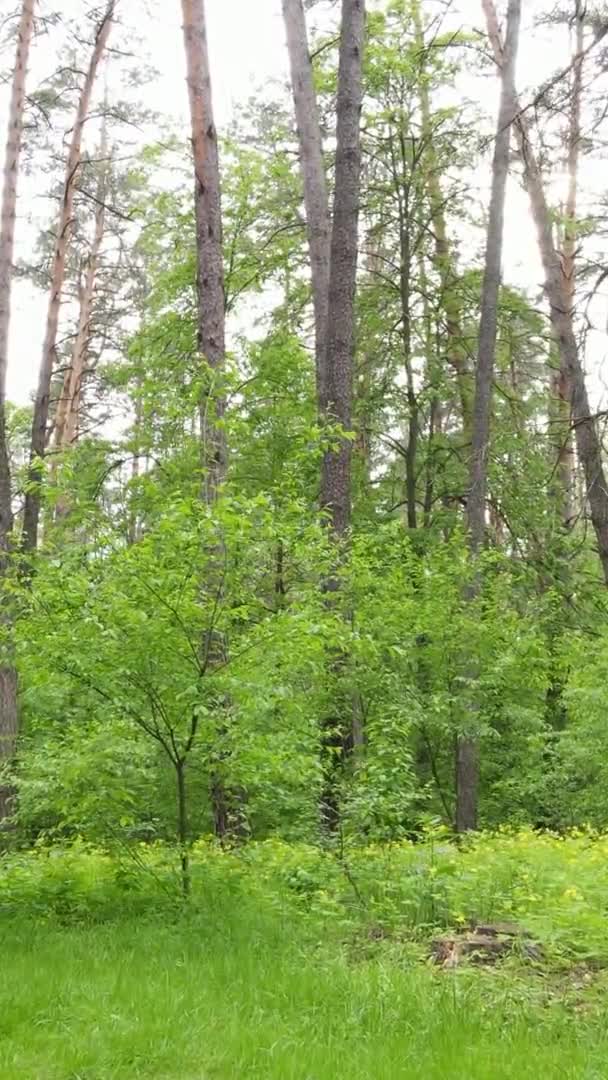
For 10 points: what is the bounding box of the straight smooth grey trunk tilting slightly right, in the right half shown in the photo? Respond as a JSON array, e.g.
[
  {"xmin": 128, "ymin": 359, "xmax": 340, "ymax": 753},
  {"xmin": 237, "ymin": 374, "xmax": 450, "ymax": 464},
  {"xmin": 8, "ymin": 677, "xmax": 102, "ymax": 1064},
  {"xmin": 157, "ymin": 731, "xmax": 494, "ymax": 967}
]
[{"xmin": 456, "ymin": 0, "xmax": 521, "ymax": 833}]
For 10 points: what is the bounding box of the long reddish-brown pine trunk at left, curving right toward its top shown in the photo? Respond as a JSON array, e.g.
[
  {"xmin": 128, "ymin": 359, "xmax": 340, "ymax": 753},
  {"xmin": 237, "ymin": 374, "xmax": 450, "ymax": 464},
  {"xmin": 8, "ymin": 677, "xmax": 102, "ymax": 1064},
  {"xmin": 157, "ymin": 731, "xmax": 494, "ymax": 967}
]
[{"xmin": 23, "ymin": 0, "xmax": 116, "ymax": 552}]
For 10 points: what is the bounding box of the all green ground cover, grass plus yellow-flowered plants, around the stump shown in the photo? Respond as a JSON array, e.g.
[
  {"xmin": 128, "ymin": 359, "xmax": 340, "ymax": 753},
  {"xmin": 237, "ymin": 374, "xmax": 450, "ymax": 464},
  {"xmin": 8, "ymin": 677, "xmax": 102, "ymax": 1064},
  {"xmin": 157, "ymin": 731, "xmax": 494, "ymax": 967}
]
[{"xmin": 0, "ymin": 831, "xmax": 608, "ymax": 1080}]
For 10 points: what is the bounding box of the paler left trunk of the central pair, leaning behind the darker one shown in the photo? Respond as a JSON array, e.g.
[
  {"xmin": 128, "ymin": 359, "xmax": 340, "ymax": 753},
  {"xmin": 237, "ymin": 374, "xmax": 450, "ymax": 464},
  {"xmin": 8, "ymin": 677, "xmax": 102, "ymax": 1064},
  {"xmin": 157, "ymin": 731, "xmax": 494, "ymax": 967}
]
[{"xmin": 283, "ymin": 0, "xmax": 330, "ymax": 403}]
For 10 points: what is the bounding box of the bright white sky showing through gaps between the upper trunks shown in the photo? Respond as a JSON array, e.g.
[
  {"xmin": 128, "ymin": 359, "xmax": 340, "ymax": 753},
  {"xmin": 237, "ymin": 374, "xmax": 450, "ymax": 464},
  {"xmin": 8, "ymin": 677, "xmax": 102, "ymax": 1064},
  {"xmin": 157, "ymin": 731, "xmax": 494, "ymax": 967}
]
[{"xmin": 0, "ymin": 0, "xmax": 605, "ymax": 404}]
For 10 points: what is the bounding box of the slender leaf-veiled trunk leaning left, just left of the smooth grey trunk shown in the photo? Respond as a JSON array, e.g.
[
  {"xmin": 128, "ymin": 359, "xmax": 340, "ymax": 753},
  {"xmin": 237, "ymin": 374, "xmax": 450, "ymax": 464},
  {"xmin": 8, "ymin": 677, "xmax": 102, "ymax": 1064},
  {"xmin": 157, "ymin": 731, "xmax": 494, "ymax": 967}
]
[{"xmin": 413, "ymin": 0, "xmax": 473, "ymax": 446}]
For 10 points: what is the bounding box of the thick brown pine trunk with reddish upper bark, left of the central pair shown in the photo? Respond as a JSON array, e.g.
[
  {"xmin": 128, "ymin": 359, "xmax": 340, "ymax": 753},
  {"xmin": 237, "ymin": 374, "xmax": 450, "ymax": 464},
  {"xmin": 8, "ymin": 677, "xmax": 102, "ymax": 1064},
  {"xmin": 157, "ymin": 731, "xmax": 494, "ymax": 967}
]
[{"xmin": 181, "ymin": 0, "xmax": 241, "ymax": 838}]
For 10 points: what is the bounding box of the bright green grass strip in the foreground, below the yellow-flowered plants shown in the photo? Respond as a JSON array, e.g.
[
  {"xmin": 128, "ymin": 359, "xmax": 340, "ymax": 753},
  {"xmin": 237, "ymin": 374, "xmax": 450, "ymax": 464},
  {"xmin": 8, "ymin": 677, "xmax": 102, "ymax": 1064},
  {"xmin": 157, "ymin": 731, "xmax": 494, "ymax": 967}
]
[{"xmin": 0, "ymin": 906, "xmax": 608, "ymax": 1080}]
